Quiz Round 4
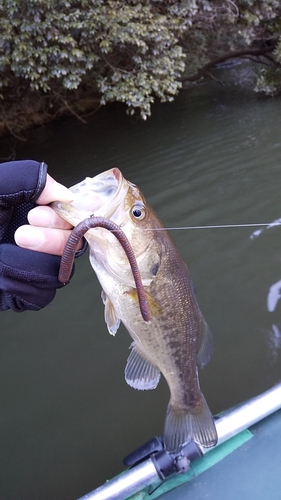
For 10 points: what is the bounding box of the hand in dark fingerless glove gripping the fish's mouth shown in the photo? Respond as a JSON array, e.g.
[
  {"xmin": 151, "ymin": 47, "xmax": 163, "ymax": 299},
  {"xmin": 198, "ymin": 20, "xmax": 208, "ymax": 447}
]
[{"xmin": 0, "ymin": 160, "xmax": 81, "ymax": 312}]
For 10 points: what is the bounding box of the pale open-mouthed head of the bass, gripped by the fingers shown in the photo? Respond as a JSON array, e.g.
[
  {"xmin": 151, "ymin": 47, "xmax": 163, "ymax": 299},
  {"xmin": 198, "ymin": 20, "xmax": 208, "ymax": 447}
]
[{"xmin": 52, "ymin": 168, "xmax": 162, "ymax": 285}]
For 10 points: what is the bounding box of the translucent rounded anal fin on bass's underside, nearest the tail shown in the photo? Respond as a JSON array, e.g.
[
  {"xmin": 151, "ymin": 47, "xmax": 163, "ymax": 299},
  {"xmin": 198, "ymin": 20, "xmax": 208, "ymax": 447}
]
[{"xmin": 125, "ymin": 343, "xmax": 161, "ymax": 391}]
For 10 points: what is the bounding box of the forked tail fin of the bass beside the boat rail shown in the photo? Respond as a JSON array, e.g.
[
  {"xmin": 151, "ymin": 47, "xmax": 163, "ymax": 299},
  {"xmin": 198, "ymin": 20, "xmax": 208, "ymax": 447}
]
[{"xmin": 164, "ymin": 394, "xmax": 218, "ymax": 452}]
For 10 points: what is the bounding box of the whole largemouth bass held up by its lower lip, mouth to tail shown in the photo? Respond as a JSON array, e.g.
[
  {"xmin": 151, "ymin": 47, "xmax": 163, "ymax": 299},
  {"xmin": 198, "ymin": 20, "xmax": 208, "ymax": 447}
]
[{"xmin": 52, "ymin": 168, "xmax": 217, "ymax": 452}]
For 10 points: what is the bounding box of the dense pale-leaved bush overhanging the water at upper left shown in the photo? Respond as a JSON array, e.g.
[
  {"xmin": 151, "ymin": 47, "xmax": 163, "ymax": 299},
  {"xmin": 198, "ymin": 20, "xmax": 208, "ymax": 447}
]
[{"xmin": 0, "ymin": 0, "xmax": 187, "ymax": 118}]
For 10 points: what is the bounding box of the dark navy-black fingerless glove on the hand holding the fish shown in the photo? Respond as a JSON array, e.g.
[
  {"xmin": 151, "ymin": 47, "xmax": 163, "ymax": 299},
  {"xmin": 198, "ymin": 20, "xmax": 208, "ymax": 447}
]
[{"xmin": 0, "ymin": 160, "xmax": 68, "ymax": 312}]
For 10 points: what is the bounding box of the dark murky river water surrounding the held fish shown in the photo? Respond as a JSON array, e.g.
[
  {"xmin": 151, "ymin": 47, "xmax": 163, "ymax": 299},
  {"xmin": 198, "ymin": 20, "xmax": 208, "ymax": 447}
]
[{"xmin": 0, "ymin": 75, "xmax": 281, "ymax": 500}]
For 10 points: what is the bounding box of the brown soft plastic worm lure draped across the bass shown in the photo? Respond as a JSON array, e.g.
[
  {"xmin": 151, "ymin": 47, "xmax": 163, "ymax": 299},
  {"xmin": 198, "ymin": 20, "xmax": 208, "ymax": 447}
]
[{"xmin": 58, "ymin": 216, "xmax": 150, "ymax": 322}]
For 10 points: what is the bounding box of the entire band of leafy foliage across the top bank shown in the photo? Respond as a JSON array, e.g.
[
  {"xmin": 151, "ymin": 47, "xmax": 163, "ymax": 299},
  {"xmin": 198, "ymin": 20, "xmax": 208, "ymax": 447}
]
[{"xmin": 0, "ymin": 0, "xmax": 281, "ymax": 124}]
